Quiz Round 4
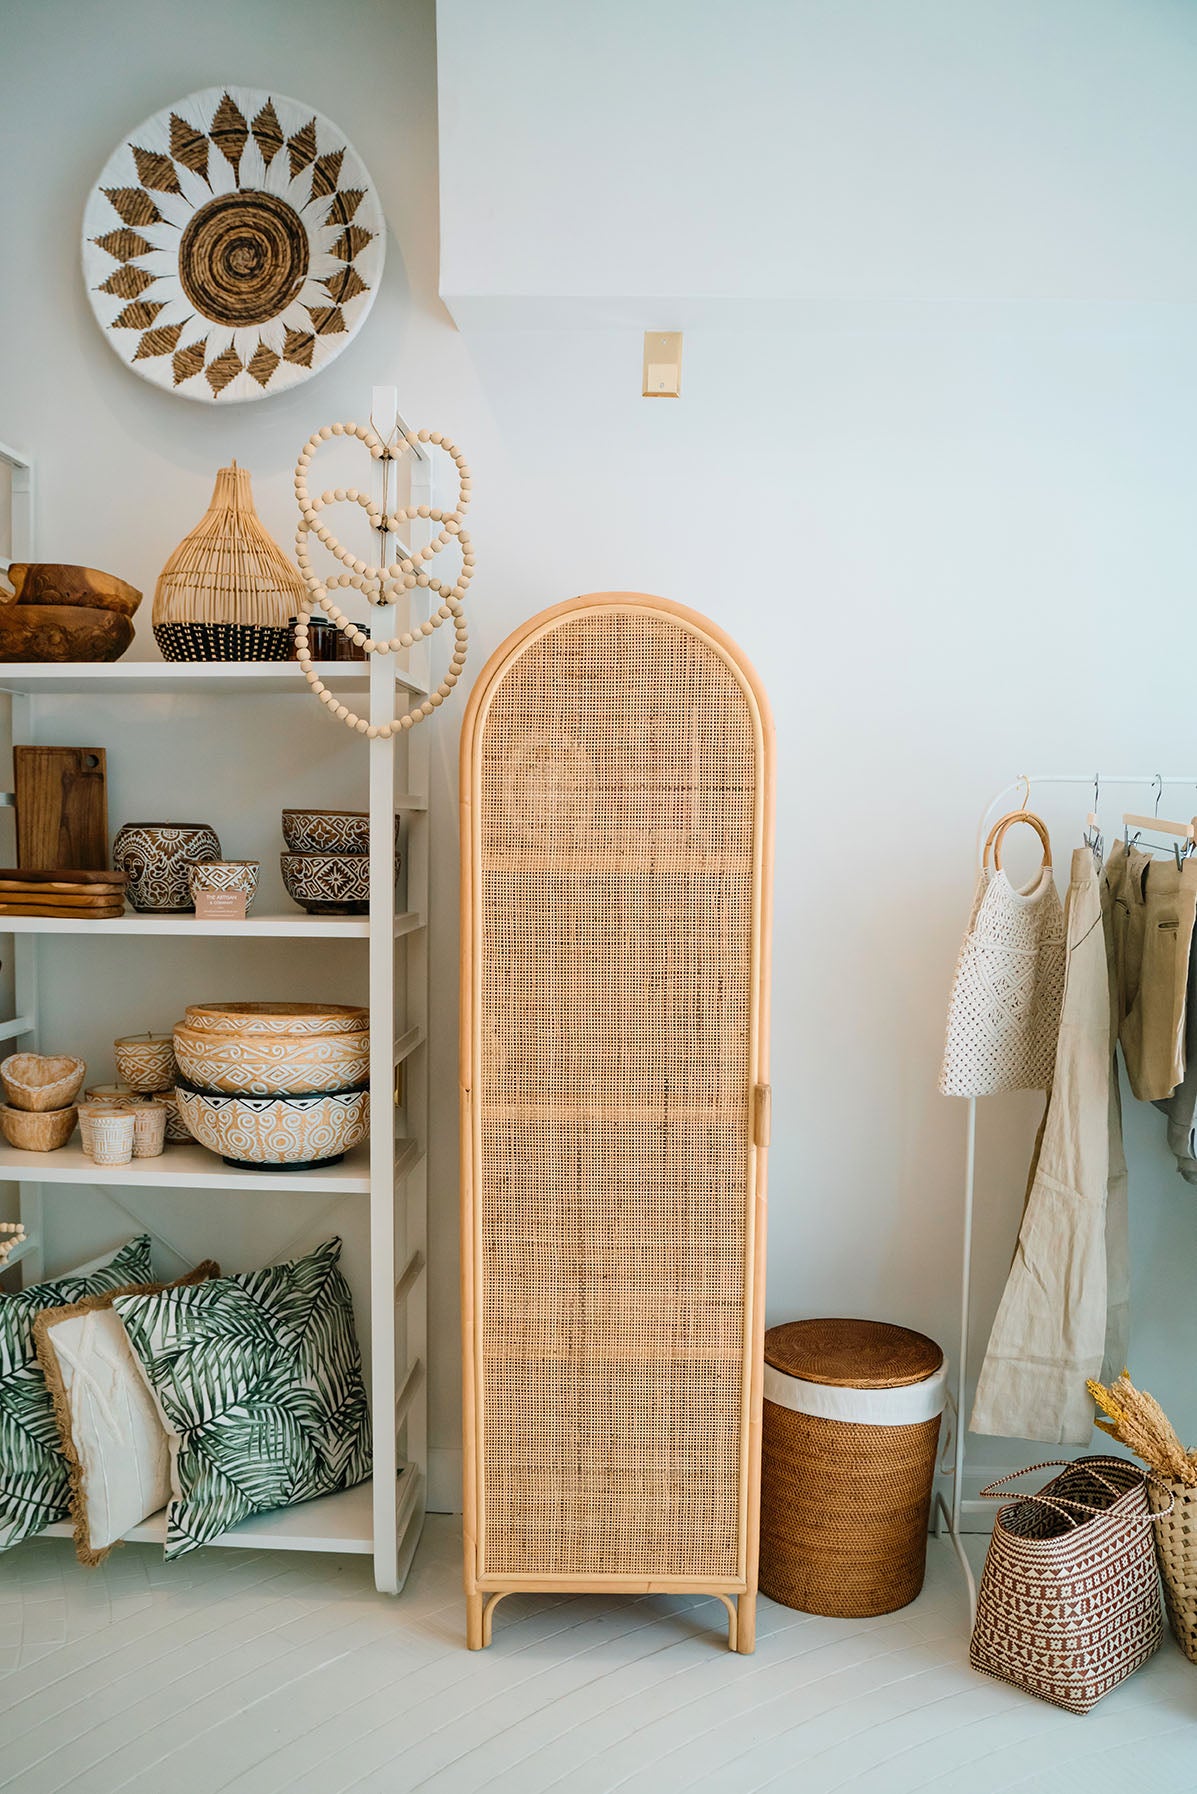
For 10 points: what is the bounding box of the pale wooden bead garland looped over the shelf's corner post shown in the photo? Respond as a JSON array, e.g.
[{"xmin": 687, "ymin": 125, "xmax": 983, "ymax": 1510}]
[{"xmin": 294, "ymin": 423, "xmax": 474, "ymax": 741}]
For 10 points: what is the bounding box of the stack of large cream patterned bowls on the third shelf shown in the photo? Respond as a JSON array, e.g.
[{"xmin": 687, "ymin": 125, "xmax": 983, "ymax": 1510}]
[{"xmin": 174, "ymin": 1003, "xmax": 370, "ymax": 1171}]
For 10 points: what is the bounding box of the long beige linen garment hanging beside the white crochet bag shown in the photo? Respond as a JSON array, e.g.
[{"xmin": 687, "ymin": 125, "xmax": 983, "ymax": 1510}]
[{"xmin": 971, "ymin": 847, "xmax": 1125, "ymax": 1444}]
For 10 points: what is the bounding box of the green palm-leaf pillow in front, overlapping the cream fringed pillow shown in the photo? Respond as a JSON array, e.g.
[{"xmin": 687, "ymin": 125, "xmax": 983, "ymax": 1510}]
[{"xmin": 113, "ymin": 1240, "xmax": 370, "ymax": 1559}]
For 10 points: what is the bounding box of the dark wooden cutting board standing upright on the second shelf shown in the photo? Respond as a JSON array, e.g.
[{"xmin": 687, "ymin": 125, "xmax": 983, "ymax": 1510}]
[{"xmin": 13, "ymin": 748, "xmax": 108, "ymax": 872}]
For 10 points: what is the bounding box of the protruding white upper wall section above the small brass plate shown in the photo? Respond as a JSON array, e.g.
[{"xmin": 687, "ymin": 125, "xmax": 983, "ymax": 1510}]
[{"xmin": 436, "ymin": 0, "xmax": 1197, "ymax": 323}]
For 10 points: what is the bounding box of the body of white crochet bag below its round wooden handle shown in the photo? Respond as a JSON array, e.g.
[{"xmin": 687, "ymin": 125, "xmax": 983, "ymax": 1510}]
[{"xmin": 939, "ymin": 865, "xmax": 1064, "ymax": 1096}]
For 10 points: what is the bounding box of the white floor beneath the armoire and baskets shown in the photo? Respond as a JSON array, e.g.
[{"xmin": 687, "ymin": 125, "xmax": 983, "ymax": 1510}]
[{"xmin": 0, "ymin": 1518, "xmax": 1197, "ymax": 1794}]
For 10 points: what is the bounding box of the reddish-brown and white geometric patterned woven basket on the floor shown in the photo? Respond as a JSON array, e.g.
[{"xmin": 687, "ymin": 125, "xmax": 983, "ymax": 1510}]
[{"xmin": 969, "ymin": 1457, "xmax": 1163, "ymax": 1713}]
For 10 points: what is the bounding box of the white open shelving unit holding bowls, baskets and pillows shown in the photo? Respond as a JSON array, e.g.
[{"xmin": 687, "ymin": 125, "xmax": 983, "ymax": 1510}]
[{"xmin": 0, "ymin": 642, "xmax": 429, "ymax": 1593}]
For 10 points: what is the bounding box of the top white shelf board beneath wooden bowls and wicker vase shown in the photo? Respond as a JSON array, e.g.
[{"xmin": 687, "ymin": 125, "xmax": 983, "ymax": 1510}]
[{"xmin": 0, "ymin": 660, "xmax": 427, "ymax": 698}]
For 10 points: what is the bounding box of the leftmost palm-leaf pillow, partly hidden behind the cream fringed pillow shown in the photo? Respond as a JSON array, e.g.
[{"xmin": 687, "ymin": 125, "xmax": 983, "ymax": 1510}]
[{"xmin": 0, "ymin": 1234, "xmax": 154, "ymax": 1550}]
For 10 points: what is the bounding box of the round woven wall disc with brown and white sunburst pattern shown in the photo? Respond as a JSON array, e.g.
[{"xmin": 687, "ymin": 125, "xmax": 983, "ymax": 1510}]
[{"xmin": 83, "ymin": 88, "xmax": 386, "ymax": 404}]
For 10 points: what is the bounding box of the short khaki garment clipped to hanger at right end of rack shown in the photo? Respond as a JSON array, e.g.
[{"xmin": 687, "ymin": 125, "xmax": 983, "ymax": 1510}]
[{"xmin": 1104, "ymin": 843, "xmax": 1197, "ymax": 1103}]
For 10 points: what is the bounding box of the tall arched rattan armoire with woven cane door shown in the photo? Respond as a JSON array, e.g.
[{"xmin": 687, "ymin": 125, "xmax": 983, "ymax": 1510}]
[{"xmin": 461, "ymin": 592, "xmax": 773, "ymax": 1650}]
